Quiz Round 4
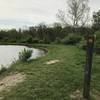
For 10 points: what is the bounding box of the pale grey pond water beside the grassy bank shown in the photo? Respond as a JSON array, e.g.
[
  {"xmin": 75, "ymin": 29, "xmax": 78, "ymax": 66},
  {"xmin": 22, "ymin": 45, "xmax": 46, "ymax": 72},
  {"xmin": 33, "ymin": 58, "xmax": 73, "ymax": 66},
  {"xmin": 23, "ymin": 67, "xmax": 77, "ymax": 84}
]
[{"xmin": 0, "ymin": 45, "xmax": 45, "ymax": 69}]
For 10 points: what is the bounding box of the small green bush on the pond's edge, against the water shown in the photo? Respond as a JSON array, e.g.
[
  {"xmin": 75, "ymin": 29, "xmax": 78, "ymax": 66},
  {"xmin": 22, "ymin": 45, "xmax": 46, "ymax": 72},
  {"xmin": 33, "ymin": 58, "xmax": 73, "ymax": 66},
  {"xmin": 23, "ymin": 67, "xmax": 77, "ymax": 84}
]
[{"xmin": 19, "ymin": 49, "xmax": 33, "ymax": 61}]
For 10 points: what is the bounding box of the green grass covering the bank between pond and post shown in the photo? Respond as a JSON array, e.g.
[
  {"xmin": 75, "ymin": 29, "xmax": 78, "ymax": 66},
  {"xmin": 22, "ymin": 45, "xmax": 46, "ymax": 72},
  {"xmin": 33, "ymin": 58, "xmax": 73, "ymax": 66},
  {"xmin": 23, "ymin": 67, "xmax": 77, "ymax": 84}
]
[{"xmin": 0, "ymin": 45, "xmax": 100, "ymax": 100}]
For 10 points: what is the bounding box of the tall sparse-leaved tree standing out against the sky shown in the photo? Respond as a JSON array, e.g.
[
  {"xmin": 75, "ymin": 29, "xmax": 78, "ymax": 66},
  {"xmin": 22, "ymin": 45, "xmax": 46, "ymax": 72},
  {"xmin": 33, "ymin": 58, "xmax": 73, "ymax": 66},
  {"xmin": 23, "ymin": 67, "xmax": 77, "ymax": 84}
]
[{"xmin": 57, "ymin": 0, "xmax": 90, "ymax": 27}]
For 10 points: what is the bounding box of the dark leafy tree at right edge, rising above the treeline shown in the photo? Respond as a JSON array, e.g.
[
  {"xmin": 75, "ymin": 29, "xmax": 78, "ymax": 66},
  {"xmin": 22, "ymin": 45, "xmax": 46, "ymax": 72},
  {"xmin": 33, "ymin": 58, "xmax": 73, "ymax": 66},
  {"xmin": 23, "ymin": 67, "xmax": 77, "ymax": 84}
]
[{"xmin": 93, "ymin": 10, "xmax": 100, "ymax": 30}]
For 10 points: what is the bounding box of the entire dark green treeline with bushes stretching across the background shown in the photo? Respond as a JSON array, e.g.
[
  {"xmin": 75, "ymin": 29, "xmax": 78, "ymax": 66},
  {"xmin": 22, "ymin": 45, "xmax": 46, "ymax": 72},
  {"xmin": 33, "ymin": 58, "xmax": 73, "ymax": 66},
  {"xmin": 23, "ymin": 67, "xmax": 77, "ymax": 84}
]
[{"xmin": 0, "ymin": 17, "xmax": 100, "ymax": 54}]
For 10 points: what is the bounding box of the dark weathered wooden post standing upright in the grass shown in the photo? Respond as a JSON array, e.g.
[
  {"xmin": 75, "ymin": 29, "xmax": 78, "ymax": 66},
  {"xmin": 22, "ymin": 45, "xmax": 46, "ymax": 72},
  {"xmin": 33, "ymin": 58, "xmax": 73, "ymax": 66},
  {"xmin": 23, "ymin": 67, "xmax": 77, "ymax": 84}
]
[{"xmin": 83, "ymin": 36, "xmax": 94, "ymax": 100}]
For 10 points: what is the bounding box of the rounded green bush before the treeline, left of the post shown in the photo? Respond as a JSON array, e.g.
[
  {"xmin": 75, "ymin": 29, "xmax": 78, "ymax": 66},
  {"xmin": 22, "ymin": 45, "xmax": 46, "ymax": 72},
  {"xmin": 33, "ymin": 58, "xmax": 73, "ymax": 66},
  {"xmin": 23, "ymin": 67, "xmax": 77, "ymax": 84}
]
[{"xmin": 62, "ymin": 34, "xmax": 82, "ymax": 45}]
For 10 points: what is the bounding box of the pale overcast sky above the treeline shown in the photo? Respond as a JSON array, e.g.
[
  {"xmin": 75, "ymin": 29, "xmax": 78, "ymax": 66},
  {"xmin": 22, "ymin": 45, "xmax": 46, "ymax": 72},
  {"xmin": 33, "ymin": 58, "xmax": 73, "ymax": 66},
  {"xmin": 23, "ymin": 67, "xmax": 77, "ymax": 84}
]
[{"xmin": 0, "ymin": 0, "xmax": 100, "ymax": 28}]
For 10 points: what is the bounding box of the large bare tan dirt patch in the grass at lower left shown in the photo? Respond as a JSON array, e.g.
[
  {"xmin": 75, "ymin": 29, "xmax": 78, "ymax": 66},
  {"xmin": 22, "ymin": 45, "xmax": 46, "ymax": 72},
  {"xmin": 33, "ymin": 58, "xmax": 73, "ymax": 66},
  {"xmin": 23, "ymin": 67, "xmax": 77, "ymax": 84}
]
[{"xmin": 0, "ymin": 73, "xmax": 25, "ymax": 92}]
